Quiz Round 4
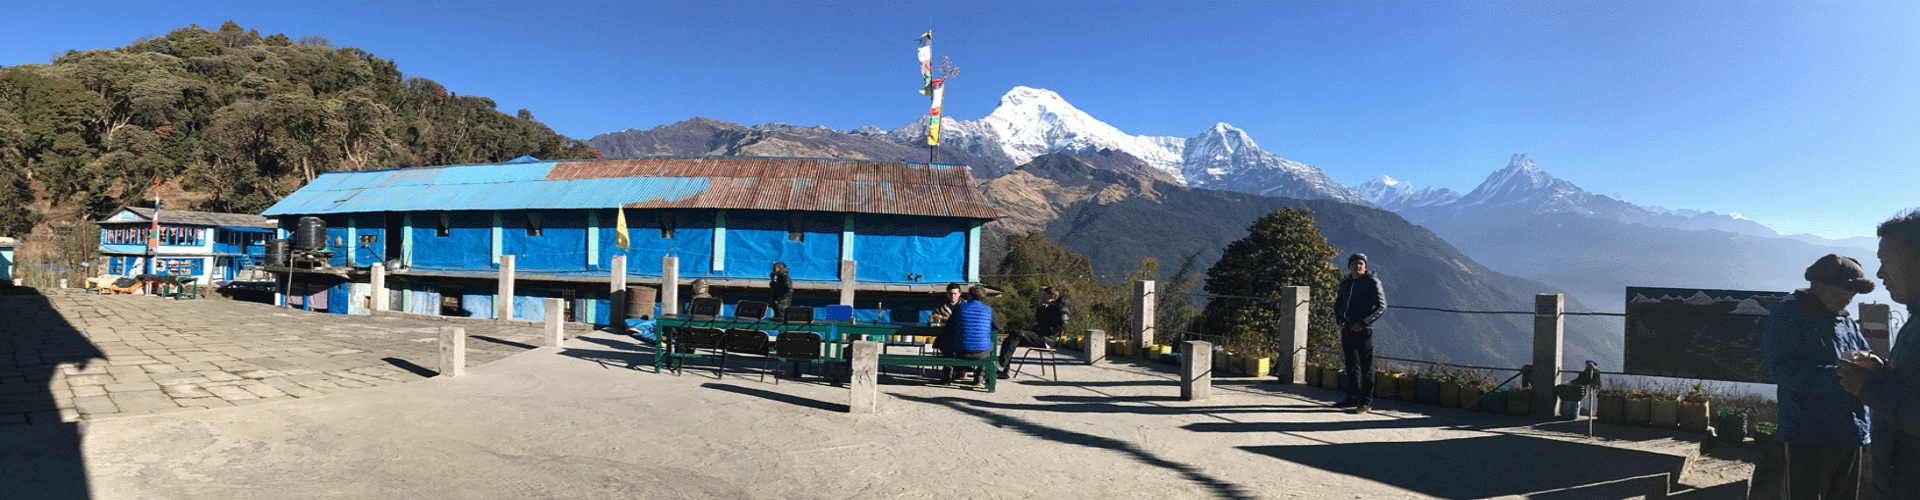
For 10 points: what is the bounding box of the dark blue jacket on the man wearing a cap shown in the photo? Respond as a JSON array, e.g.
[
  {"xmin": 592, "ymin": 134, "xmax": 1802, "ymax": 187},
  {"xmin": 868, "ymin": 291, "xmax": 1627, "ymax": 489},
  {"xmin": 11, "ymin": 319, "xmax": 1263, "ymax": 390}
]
[{"xmin": 1761, "ymin": 290, "xmax": 1868, "ymax": 446}]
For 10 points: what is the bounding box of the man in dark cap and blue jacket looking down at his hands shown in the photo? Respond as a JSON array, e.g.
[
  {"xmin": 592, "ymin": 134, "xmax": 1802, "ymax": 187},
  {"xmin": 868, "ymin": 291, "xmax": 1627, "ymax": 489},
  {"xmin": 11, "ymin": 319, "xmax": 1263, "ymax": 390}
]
[{"xmin": 1761, "ymin": 254, "xmax": 1874, "ymax": 498}]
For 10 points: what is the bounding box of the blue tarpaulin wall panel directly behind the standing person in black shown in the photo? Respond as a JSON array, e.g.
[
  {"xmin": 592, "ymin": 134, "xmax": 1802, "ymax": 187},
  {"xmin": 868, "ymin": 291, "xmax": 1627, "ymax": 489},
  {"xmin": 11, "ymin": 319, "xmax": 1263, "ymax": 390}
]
[{"xmin": 714, "ymin": 210, "xmax": 845, "ymax": 281}]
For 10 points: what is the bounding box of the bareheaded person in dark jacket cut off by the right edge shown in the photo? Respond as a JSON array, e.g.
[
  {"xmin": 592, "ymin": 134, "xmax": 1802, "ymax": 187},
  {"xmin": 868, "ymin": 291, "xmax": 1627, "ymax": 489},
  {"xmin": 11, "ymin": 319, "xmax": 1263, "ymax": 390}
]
[{"xmin": 1839, "ymin": 210, "xmax": 1920, "ymax": 498}]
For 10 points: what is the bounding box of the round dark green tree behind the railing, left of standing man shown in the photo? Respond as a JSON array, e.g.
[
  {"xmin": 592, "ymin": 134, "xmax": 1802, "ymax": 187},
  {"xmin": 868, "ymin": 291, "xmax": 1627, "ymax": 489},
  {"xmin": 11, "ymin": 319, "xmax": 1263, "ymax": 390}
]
[{"xmin": 1202, "ymin": 208, "xmax": 1340, "ymax": 360}]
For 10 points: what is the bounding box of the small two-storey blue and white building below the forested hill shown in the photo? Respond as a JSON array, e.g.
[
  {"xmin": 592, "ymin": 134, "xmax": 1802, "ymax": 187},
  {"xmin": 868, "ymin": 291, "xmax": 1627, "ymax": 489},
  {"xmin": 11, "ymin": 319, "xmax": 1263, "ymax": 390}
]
[{"xmin": 100, "ymin": 206, "xmax": 273, "ymax": 285}]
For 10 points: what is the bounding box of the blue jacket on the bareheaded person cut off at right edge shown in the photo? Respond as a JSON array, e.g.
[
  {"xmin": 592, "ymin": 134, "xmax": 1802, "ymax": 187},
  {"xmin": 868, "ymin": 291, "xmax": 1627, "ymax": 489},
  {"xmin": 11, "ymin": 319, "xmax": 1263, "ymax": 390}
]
[{"xmin": 1860, "ymin": 317, "xmax": 1920, "ymax": 498}]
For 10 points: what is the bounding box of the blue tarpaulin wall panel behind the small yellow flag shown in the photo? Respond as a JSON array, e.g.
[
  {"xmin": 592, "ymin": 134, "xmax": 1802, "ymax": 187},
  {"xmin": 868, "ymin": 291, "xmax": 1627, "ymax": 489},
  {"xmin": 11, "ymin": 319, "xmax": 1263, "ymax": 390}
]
[{"xmin": 599, "ymin": 210, "xmax": 714, "ymax": 281}]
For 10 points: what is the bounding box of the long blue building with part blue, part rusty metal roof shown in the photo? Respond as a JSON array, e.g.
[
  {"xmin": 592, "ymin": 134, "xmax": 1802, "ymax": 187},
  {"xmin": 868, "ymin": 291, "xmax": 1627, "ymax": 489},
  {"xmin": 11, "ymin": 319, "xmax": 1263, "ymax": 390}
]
[{"xmin": 263, "ymin": 158, "xmax": 1000, "ymax": 323}]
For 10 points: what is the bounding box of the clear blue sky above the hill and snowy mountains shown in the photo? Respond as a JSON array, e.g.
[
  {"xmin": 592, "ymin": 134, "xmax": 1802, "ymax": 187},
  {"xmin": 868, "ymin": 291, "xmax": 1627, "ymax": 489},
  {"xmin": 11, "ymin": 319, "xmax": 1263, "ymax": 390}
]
[{"xmin": 0, "ymin": 0, "xmax": 1920, "ymax": 237}]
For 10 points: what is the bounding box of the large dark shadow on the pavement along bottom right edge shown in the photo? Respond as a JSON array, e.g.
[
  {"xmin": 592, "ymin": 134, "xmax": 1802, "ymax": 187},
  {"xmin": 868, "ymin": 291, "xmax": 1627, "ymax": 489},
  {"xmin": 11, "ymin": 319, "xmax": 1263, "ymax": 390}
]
[{"xmin": 1240, "ymin": 427, "xmax": 1682, "ymax": 498}]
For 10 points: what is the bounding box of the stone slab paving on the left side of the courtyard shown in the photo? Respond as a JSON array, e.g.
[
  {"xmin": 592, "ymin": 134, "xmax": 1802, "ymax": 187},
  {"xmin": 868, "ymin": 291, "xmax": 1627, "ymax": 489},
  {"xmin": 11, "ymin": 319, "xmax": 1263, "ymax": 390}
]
[{"xmin": 0, "ymin": 288, "xmax": 540, "ymax": 425}]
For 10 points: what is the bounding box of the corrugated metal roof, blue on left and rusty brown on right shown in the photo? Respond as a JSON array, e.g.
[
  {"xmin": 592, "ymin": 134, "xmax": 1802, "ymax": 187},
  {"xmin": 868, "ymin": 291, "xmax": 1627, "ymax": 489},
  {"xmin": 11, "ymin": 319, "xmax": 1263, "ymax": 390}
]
[{"xmin": 263, "ymin": 158, "xmax": 1000, "ymax": 219}]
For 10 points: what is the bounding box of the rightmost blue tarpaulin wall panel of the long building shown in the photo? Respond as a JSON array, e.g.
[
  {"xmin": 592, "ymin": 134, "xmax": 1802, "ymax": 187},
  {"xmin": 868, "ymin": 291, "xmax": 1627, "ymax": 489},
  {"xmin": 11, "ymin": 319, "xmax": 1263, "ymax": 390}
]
[{"xmin": 852, "ymin": 213, "xmax": 966, "ymax": 283}]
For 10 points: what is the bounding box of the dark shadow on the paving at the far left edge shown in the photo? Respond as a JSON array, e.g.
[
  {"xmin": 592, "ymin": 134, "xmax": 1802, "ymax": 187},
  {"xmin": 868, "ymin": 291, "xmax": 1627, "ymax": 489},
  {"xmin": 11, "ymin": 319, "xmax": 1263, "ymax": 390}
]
[{"xmin": 0, "ymin": 287, "xmax": 108, "ymax": 498}]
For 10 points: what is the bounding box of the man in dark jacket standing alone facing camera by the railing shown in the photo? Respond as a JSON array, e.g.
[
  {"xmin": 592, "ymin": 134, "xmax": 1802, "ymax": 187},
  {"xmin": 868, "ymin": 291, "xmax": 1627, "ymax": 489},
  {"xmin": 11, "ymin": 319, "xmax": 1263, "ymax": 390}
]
[{"xmin": 1332, "ymin": 254, "xmax": 1386, "ymax": 413}]
